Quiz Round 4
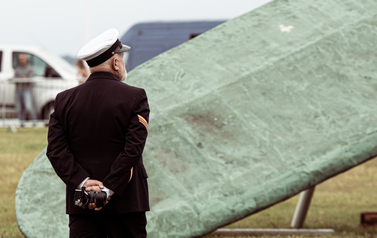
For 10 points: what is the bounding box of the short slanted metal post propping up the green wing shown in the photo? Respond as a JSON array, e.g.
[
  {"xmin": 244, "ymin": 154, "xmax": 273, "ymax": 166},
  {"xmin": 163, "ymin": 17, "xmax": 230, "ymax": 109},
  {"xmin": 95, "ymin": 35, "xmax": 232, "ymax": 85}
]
[{"xmin": 291, "ymin": 186, "xmax": 315, "ymax": 228}]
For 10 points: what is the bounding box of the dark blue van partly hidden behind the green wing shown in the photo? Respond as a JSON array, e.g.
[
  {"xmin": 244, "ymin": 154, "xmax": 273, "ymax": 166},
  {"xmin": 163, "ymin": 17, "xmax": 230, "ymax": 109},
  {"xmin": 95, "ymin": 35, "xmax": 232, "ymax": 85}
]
[{"xmin": 120, "ymin": 21, "xmax": 225, "ymax": 71}]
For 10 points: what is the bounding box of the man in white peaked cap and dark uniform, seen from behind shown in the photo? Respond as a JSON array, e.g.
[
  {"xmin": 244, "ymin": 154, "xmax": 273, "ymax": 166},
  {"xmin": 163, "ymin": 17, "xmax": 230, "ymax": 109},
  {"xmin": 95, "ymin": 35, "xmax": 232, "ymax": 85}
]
[{"xmin": 47, "ymin": 29, "xmax": 149, "ymax": 237}]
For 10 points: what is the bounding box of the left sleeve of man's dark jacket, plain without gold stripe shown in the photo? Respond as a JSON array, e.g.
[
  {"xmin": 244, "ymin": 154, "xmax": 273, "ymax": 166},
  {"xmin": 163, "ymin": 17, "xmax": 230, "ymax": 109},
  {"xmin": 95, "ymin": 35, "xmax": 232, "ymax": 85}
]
[{"xmin": 46, "ymin": 95, "xmax": 89, "ymax": 190}]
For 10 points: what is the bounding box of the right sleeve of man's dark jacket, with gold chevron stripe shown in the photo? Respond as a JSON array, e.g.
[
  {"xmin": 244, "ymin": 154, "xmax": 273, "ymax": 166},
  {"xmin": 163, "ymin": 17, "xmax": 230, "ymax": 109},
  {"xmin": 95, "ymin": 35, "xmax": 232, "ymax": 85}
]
[{"xmin": 103, "ymin": 89, "xmax": 149, "ymax": 195}]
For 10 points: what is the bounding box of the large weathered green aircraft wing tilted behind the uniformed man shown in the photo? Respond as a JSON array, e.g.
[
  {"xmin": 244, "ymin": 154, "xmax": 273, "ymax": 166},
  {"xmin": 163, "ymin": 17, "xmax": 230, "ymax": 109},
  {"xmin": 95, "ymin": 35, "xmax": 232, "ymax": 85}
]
[{"xmin": 16, "ymin": 0, "xmax": 377, "ymax": 238}]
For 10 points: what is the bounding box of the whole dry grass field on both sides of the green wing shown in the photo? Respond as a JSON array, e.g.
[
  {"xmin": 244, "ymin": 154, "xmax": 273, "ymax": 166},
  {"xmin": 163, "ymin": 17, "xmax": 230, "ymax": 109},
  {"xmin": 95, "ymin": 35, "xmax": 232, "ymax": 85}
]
[{"xmin": 0, "ymin": 128, "xmax": 377, "ymax": 238}]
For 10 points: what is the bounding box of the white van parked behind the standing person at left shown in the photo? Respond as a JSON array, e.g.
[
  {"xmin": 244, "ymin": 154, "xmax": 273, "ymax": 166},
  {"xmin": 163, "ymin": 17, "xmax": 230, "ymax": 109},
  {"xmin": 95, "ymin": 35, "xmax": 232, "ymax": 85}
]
[{"xmin": 0, "ymin": 45, "xmax": 81, "ymax": 120}]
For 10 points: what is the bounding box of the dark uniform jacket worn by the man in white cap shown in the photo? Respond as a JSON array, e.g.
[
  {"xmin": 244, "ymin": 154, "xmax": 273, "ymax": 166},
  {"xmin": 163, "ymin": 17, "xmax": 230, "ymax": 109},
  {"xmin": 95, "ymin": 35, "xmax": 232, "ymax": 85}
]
[{"xmin": 46, "ymin": 72, "xmax": 149, "ymax": 214}]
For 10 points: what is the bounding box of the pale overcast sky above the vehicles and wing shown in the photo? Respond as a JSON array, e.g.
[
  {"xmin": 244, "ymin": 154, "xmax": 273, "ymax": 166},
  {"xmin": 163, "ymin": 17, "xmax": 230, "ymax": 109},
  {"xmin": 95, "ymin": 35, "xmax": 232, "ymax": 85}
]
[{"xmin": 0, "ymin": 0, "xmax": 271, "ymax": 57}]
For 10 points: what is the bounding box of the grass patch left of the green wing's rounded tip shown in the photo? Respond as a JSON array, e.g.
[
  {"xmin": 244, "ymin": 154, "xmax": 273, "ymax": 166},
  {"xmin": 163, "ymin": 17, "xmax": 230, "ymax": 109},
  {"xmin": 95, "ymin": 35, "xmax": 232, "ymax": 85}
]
[{"xmin": 0, "ymin": 128, "xmax": 47, "ymax": 238}]
